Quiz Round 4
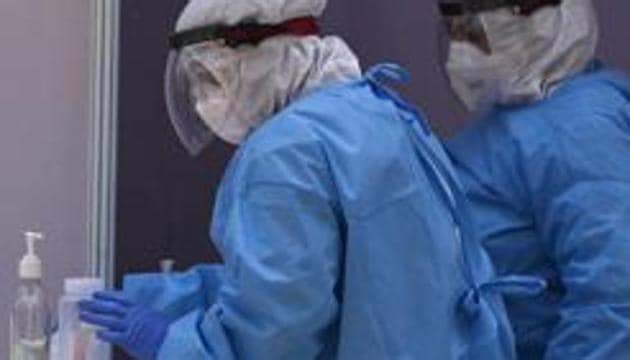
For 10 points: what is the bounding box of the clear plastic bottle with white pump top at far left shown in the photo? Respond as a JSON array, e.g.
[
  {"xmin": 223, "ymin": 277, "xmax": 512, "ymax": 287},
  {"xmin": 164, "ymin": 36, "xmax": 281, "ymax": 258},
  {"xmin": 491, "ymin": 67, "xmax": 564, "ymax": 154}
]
[{"xmin": 10, "ymin": 232, "xmax": 49, "ymax": 360}]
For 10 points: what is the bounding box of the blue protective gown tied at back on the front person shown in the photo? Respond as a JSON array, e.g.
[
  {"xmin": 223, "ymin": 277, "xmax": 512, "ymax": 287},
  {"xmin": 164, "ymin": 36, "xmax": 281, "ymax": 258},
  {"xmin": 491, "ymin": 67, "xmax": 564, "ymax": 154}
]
[{"xmin": 125, "ymin": 68, "xmax": 514, "ymax": 360}]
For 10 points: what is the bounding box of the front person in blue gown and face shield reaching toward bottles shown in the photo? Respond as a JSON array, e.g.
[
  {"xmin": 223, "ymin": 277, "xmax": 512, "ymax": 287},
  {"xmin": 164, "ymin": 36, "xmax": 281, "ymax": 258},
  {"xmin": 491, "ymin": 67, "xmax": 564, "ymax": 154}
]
[{"xmin": 81, "ymin": 0, "xmax": 524, "ymax": 360}]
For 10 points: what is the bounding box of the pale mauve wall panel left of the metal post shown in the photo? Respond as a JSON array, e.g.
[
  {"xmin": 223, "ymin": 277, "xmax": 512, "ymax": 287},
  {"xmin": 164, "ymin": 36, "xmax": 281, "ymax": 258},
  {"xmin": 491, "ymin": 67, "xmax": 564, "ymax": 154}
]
[{"xmin": 0, "ymin": 0, "xmax": 89, "ymax": 359}]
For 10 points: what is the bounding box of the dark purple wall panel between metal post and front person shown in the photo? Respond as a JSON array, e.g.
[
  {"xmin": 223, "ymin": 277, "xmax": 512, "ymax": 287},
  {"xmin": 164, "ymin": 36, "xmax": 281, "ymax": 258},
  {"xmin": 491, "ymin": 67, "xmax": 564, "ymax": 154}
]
[{"xmin": 116, "ymin": 0, "xmax": 230, "ymax": 280}]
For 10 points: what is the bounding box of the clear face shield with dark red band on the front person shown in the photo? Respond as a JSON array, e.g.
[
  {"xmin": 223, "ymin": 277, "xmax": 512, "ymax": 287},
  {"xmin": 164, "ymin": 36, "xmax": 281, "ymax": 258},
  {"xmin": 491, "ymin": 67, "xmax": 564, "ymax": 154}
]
[{"xmin": 164, "ymin": 18, "xmax": 319, "ymax": 156}]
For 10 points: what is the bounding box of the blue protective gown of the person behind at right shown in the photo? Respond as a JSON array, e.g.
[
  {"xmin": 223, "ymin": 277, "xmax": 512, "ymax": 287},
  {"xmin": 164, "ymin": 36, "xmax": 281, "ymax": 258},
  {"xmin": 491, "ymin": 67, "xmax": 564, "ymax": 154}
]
[{"xmin": 448, "ymin": 63, "xmax": 630, "ymax": 360}]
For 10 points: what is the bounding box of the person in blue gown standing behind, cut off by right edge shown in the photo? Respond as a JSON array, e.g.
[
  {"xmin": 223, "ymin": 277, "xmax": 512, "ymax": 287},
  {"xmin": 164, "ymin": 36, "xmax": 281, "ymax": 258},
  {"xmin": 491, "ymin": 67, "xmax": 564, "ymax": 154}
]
[{"xmin": 441, "ymin": 0, "xmax": 630, "ymax": 360}]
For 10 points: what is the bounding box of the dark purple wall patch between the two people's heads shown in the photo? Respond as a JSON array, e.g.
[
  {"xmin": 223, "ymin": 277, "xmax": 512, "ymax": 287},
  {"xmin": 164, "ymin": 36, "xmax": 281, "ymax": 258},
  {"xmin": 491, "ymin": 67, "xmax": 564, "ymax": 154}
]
[{"xmin": 324, "ymin": 0, "xmax": 464, "ymax": 133}]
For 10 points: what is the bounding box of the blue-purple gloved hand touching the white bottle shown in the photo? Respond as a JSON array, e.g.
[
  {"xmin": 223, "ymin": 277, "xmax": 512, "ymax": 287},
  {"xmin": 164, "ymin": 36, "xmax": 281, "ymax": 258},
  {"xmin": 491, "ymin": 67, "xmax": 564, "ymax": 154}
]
[{"xmin": 79, "ymin": 291, "xmax": 170, "ymax": 360}]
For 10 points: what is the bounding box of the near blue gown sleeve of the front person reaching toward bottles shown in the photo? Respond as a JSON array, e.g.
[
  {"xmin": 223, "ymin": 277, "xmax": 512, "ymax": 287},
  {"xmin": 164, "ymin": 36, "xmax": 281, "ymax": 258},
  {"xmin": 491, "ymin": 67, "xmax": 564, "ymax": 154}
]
[{"xmin": 158, "ymin": 139, "xmax": 342, "ymax": 360}]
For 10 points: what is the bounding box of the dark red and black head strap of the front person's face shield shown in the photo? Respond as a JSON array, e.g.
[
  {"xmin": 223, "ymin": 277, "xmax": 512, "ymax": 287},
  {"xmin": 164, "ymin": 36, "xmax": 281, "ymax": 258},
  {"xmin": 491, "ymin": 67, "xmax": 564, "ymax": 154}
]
[{"xmin": 169, "ymin": 17, "xmax": 320, "ymax": 50}]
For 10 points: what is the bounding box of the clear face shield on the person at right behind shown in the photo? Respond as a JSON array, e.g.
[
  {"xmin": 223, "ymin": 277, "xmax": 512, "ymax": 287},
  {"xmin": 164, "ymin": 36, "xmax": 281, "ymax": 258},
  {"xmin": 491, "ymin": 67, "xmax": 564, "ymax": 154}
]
[{"xmin": 438, "ymin": 0, "xmax": 562, "ymax": 110}]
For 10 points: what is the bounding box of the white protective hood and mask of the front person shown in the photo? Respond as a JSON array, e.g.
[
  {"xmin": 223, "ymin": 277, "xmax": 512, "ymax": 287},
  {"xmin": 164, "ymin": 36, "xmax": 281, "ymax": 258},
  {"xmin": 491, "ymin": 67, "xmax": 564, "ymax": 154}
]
[{"xmin": 167, "ymin": 0, "xmax": 361, "ymax": 149}]
